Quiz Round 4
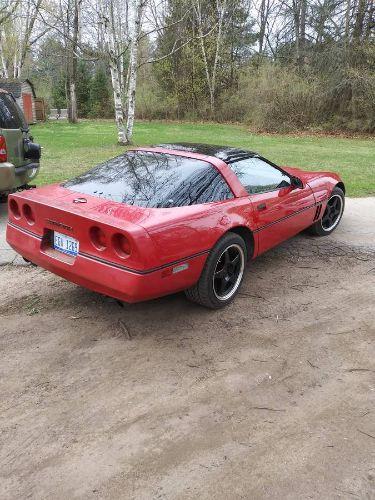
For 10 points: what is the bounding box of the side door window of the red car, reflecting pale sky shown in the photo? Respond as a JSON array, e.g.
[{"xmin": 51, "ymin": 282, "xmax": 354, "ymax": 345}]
[{"xmin": 230, "ymin": 158, "xmax": 290, "ymax": 194}]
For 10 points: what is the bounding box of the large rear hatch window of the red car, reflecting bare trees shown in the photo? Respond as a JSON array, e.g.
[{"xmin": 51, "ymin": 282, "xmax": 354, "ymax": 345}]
[{"xmin": 63, "ymin": 151, "xmax": 233, "ymax": 208}]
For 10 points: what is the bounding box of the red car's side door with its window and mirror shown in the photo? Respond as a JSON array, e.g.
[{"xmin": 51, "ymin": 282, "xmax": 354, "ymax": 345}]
[{"xmin": 230, "ymin": 157, "xmax": 316, "ymax": 254}]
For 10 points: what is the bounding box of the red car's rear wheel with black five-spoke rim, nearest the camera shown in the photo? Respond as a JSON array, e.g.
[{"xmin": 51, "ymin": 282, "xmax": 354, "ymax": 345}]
[{"xmin": 185, "ymin": 232, "xmax": 247, "ymax": 309}]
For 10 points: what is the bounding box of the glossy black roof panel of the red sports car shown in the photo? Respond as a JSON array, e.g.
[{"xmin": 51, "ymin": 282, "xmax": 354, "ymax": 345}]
[{"xmin": 154, "ymin": 142, "xmax": 257, "ymax": 163}]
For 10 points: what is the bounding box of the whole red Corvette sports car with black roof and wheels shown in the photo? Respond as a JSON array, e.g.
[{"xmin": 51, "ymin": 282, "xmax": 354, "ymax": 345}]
[{"xmin": 7, "ymin": 144, "xmax": 345, "ymax": 308}]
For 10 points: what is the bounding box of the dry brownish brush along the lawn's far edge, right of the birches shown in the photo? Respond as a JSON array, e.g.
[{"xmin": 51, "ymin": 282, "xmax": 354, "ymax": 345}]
[{"xmin": 145, "ymin": 45, "xmax": 375, "ymax": 132}]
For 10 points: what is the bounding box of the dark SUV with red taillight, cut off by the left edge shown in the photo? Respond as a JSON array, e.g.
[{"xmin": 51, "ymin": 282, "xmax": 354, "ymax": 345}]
[{"xmin": 0, "ymin": 89, "xmax": 41, "ymax": 197}]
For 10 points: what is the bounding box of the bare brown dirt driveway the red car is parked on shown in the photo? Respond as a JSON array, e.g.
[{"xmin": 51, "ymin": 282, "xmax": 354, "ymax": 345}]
[{"xmin": 0, "ymin": 202, "xmax": 375, "ymax": 500}]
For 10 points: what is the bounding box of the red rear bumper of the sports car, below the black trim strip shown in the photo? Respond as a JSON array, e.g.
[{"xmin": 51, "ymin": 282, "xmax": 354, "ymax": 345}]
[{"xmin": 7, "ymin": 223, "xmax": 208, "ymax": 303}]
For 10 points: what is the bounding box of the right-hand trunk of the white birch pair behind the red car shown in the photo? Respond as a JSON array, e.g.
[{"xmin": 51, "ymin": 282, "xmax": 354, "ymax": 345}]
[{"xmin": 126, "ymin": 0, "xmax": 144, "ymax": 144}]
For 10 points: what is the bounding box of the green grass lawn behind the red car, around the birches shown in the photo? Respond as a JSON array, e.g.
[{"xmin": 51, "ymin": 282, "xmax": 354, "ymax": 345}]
[{"xmin": 32, "ymin": 120, "xmax": 375, "ymax": 196}]
